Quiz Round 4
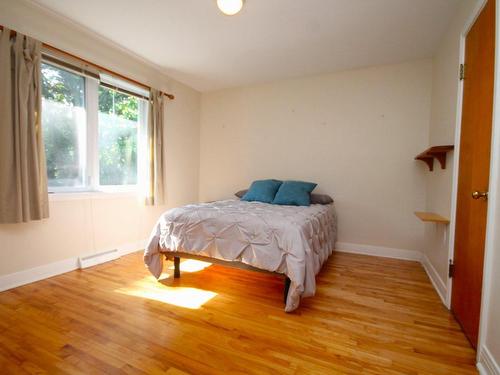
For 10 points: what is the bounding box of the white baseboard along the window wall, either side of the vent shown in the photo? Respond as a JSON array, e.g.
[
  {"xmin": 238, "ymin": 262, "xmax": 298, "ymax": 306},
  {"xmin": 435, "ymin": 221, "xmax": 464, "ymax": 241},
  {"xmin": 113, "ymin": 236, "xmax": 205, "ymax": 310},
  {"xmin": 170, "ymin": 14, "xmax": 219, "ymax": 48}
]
[{"xmin": 0, "ymin": 240, "xmax": 146, "ymax": 292}]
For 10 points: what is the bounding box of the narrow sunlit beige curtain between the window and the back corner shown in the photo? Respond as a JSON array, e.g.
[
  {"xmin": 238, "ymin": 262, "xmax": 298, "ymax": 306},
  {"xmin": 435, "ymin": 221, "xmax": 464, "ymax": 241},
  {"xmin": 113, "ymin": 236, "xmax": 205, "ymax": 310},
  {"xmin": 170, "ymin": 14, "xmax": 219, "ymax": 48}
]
[{"xmin": 145, "ymin": 89, "xmax": 165, "ymax": 206}]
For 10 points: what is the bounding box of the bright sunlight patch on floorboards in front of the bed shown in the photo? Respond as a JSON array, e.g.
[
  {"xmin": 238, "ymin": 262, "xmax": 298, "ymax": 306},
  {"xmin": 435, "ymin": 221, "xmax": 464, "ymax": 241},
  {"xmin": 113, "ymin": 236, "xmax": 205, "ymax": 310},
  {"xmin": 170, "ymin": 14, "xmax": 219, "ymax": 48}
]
[{"xmin": 115, "ymin": 280, "xmax": 217, "ymax": 309}]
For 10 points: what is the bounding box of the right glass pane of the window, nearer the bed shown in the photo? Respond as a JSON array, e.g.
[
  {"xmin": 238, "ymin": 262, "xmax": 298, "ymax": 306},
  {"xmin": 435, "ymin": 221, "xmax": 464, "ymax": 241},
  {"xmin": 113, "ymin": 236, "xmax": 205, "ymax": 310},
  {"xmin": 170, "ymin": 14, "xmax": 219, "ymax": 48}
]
[{"xmin": 99, "ymin": 86, "xmax": 140, "ymax": 185}]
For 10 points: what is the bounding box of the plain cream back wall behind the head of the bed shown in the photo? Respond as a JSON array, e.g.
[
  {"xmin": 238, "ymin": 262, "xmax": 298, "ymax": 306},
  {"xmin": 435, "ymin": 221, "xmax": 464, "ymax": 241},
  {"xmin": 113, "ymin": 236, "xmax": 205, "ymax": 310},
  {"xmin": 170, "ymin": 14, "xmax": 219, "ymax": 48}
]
[{"xmin": 200, "ymin": 60, "xmax": 432, "ymax": 256}]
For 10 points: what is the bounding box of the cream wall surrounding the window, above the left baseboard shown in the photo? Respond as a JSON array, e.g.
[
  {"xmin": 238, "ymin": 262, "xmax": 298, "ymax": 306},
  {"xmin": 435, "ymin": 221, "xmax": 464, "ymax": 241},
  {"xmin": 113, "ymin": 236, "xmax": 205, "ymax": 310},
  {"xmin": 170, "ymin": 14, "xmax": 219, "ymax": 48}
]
[{"xmin": 0, "ymin": 0, "xmax": 200, "ymax": 276}]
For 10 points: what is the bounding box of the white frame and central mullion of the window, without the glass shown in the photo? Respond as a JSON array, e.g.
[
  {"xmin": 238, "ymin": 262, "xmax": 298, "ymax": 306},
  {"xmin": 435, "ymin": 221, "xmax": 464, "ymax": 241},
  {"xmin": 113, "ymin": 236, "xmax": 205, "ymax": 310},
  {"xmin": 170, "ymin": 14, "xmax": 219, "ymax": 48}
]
[{"xmin": 42, "ymin": 56, "xmax": 149, "ymax": 194}]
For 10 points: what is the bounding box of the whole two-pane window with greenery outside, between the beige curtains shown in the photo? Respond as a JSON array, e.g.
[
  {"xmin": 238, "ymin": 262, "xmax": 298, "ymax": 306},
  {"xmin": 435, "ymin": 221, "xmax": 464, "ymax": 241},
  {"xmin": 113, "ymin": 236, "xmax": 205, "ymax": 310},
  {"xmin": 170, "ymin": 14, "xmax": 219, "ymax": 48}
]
[{"xmin": 42, "ymin": 62, "xmax": 148, "ymax": 192}]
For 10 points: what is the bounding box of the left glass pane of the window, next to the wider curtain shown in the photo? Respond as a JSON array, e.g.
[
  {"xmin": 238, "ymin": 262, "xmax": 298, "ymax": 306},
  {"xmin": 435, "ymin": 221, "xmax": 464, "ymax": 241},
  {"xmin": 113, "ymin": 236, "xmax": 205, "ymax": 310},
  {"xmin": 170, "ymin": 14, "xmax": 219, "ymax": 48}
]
[{"xmin": 42, "ymin": 64, "xmax": 86, "ymax": 191}]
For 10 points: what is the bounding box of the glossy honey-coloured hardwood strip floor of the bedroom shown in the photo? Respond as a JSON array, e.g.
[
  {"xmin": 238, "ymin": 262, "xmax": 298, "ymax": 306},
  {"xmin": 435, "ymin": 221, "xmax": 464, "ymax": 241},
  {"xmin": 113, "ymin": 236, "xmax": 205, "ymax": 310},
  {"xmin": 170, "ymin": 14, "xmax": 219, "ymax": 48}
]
[{"xmin": 0, "ymin": 253, "xmax": 476, "ymax": 375}]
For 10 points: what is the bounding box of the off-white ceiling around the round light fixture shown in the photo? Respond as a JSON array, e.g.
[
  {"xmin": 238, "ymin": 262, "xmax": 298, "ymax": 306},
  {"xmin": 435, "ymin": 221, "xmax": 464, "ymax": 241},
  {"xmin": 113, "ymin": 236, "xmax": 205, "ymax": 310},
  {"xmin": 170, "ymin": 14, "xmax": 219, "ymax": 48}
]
[{"xmin": 35, "ymin": 0, "xmax": 460, "ymax": 91}]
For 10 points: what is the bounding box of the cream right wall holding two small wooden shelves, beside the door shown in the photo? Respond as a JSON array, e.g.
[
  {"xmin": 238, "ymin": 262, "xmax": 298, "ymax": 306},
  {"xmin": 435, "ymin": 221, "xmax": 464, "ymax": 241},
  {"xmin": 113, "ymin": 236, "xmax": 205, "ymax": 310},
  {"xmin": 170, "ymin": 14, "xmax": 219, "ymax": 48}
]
[{"xmin": 423, "ymin": 0, "xmax": 477, "ymax": 297}]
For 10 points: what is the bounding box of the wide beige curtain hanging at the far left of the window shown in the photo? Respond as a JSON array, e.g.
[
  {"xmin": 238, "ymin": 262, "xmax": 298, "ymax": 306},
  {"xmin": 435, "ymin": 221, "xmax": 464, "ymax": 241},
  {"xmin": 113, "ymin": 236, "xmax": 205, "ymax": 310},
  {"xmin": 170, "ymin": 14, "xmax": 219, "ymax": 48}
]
[{"xmin": 0, "ymin": 28, "xmax": 49, "ymax": 223}]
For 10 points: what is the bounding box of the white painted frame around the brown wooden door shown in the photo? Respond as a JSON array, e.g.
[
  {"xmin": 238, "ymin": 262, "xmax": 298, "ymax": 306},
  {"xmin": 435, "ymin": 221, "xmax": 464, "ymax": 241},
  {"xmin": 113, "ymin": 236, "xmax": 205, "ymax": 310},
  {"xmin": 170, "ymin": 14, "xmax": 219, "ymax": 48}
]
[{"xmin": 446, "ymin": 0, "xmax": 500, "ymax": 363}]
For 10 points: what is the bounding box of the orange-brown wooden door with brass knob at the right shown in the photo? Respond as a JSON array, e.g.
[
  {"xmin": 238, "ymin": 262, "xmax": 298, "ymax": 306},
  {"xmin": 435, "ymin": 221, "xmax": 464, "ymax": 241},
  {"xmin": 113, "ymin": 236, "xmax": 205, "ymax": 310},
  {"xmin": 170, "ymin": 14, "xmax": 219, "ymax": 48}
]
[{"xmin": 451, "ymin": 0, "xmax": 495, "ymax": 347}]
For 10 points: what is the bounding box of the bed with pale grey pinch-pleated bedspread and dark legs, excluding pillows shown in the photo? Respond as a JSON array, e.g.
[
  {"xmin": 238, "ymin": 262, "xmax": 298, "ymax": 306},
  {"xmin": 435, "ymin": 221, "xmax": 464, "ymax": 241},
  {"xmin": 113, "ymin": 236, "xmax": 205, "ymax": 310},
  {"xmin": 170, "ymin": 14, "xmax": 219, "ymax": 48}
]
[{"xmin": 144, "ymin": 199, "xmax": 337, "ymax": 312}]
